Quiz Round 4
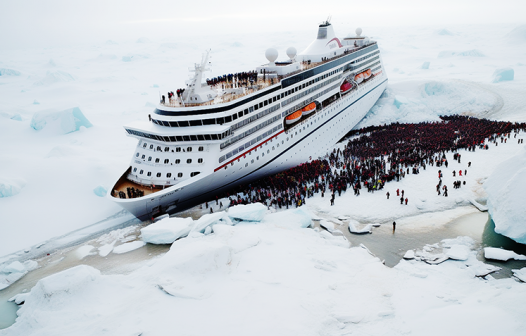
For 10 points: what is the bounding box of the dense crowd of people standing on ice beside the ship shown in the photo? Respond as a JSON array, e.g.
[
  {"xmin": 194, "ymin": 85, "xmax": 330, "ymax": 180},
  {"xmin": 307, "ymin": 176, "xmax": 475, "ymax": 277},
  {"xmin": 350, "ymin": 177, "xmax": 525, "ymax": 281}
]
[{"xmin": 207, "ymin": 116, "xmax": 526, "ymax": 211}]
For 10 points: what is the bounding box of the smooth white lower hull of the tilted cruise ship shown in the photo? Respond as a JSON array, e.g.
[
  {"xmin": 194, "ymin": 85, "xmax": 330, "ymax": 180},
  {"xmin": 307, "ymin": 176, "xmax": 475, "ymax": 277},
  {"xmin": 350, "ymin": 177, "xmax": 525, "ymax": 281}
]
[{"xmin": 109, "ymin": 72, "xmax": 387, "ymax": 219}]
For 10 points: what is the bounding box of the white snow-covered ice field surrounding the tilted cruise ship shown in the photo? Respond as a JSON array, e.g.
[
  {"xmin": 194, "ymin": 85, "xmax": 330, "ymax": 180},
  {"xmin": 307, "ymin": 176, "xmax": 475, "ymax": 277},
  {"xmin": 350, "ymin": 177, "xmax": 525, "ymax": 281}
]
[{"xmin": 0, "ymin": 21, "xmax": 526, "ymax": 335}]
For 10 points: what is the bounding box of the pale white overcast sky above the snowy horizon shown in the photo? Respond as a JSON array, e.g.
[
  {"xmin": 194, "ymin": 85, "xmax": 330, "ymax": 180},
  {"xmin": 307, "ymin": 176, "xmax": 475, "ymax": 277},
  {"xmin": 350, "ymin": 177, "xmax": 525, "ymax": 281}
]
[{"xmin": 0, "ymin": 0, "xmax": 526, "ymax": 48}]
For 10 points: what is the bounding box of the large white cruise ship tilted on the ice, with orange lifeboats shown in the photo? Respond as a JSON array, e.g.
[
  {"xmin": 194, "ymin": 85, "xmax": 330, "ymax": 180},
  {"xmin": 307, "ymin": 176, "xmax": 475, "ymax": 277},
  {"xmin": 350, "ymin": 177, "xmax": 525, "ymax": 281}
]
[{"xmin": 108, "ymin": 20, "xmax": 387, "ymax": 220}]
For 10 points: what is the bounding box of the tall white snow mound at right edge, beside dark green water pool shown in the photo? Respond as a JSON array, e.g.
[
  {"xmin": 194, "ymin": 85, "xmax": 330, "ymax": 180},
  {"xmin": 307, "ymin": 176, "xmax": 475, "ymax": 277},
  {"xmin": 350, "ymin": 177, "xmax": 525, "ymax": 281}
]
[{"xmin": 484, "ymin": 147, "xmax": 526, "ymax": 244}]
